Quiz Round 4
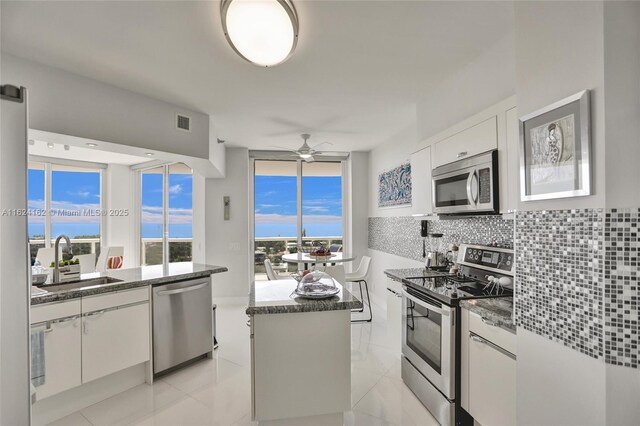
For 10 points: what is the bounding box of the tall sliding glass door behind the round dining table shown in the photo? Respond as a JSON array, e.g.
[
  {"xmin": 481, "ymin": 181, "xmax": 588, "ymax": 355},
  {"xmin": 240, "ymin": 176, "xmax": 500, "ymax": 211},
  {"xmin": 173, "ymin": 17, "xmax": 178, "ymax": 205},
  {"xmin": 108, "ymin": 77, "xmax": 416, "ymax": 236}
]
[{"xmin": 253, "ymin": 159, "xmax": 343, "ymax": 280}]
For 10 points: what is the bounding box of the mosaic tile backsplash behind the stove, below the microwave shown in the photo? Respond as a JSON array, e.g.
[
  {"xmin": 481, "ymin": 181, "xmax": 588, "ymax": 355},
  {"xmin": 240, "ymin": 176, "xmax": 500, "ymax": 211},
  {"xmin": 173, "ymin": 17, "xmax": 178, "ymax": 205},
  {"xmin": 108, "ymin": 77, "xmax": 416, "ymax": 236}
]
[{"xmin": 369, "ymin": 216, "xmax": 513, "ymax": 261}]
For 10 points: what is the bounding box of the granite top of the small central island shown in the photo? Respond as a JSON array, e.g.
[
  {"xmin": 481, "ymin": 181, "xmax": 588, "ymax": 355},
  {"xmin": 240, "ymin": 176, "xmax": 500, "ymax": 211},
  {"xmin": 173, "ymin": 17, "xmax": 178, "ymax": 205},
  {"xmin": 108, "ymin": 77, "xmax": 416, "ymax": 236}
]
[{"xmin": 246, "ymin": 279, "xmax": 362, "ymax": 315}]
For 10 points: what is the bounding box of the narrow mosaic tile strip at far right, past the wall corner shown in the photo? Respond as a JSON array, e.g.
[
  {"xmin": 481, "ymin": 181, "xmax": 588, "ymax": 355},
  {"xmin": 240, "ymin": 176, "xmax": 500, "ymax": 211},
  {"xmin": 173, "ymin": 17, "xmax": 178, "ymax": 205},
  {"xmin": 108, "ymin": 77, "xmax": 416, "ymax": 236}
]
[{"xmin": 604, "ymin": 208, "xmax": 640, "ymax": 368}]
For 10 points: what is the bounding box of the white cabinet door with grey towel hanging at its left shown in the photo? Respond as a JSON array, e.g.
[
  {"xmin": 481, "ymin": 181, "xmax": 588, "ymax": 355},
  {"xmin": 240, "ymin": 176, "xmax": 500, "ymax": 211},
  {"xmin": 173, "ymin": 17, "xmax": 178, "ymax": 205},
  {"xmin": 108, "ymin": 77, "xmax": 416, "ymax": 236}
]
[{"xmin": 32, "ymin": 315, "xmax": 82, "ymax": 400}]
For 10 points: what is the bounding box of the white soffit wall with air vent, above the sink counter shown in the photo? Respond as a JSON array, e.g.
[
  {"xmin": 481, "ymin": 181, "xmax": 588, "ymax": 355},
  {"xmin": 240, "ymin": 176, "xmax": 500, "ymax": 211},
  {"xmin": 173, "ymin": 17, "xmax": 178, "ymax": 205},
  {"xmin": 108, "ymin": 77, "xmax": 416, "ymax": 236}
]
[{"xmin": 2, "ymin": 52, "xmax": 214, "ymax": 159}]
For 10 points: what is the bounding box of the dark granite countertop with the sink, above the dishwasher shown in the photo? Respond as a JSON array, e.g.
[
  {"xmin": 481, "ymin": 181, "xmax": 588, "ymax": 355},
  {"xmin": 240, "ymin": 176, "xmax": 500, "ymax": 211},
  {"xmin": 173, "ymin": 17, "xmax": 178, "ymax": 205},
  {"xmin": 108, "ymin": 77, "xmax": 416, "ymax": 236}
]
[{"xmin": 31, "ymin": 262, "xmax": 228, "ymax": 306}]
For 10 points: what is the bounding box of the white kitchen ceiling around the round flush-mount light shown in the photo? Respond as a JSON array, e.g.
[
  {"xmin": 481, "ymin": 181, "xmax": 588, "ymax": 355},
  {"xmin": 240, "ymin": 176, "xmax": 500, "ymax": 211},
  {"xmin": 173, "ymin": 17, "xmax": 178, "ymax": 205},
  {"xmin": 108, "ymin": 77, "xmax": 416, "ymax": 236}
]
[{"xmin": 1, "ymin": 0, "xmax": 513, "ymax": 151}]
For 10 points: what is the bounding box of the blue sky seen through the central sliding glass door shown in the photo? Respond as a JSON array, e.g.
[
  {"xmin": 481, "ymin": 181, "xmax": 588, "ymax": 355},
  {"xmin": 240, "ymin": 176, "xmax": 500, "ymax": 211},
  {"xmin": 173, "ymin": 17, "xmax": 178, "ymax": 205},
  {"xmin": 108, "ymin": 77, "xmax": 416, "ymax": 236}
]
[{"xmin": 255, "ymin": 176, "xmax": 342, "ymax": 238}]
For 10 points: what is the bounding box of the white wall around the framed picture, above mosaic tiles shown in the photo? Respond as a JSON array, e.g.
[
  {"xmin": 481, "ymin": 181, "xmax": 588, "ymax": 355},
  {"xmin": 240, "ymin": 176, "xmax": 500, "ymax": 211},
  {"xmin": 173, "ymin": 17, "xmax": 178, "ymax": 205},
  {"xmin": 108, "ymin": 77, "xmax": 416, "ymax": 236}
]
[{"xmin": 514, "ymin": 1, "xmax": 605, "ymax": 210}]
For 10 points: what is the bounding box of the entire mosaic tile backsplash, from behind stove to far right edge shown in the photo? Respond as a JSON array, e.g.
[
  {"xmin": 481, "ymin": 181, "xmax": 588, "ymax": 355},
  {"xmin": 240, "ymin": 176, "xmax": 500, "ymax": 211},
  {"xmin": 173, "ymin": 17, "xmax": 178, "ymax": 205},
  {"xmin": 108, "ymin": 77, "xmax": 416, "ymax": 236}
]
[{"xmin": 369, "ymin": 208, "xmax": 640, "ymax": 368}]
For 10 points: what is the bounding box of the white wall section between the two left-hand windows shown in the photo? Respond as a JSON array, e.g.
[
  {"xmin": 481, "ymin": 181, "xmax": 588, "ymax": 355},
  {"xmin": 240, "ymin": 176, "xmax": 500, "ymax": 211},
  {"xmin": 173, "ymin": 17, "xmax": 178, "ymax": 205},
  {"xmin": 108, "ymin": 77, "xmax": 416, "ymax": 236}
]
[{"xmin": 101, "ymin": 164, "xmax": 140, "ymax": 268}]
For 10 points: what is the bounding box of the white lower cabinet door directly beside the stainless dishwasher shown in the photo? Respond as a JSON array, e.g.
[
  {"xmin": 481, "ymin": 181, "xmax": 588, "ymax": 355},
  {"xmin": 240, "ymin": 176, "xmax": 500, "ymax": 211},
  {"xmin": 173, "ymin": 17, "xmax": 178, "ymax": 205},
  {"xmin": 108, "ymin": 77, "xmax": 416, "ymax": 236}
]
[{"xmin": 82, "ymin": 302, "xmax": 150, "ymax": 383}]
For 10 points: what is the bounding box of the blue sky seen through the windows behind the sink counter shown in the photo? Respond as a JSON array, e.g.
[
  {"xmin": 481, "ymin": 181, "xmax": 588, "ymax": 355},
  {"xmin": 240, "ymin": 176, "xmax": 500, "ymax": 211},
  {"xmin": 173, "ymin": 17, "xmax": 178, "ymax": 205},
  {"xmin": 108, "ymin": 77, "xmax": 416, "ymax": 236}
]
[{"xmin": 28, "ymin": 169, "xmax": 192, "ymax": 238}]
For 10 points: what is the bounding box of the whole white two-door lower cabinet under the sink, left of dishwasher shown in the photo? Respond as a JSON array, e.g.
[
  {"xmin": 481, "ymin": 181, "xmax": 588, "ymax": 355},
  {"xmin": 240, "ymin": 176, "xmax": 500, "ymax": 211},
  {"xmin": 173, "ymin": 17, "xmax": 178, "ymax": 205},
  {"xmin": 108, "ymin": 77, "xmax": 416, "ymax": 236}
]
[{"xmin": 31, "ymin": 287, "xmax": 151, "ymax": 400}]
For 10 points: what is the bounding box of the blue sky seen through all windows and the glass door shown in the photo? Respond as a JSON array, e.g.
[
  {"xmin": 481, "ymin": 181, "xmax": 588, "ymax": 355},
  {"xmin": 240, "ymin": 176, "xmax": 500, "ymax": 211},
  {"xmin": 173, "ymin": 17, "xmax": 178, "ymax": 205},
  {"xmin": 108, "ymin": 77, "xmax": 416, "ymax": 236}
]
[{"xmin": 28, "ymin": 169, "xmax": 342, "ymax": 238}]
